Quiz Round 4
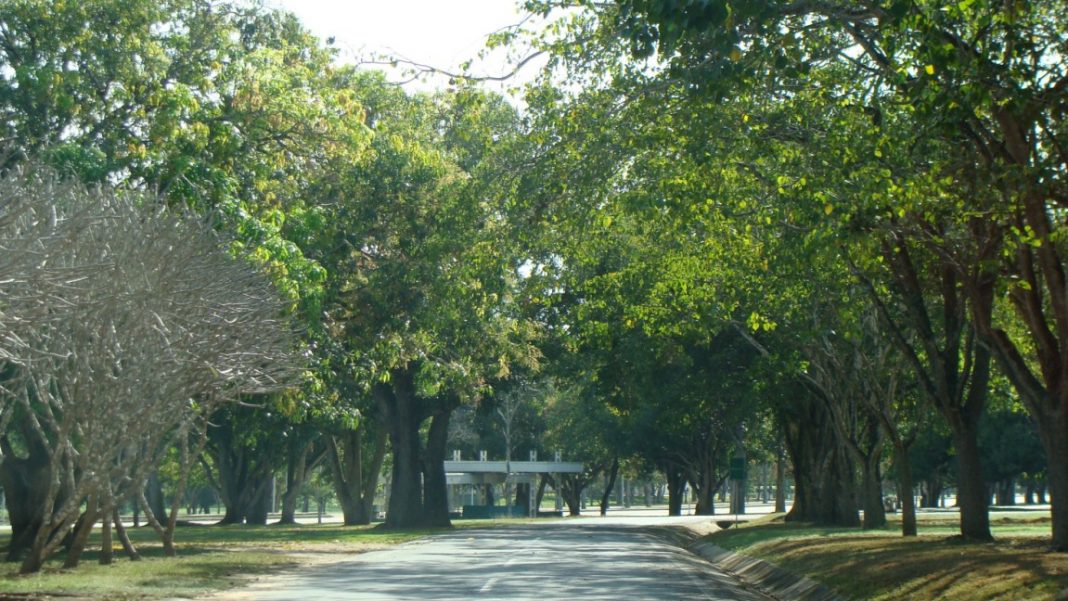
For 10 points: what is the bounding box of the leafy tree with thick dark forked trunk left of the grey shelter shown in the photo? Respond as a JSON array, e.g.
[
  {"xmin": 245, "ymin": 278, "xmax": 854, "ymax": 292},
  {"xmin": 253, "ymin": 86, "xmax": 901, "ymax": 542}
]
[{"xmin": 305, "ymin": 75, "xmax": 536, "ymax": 527}]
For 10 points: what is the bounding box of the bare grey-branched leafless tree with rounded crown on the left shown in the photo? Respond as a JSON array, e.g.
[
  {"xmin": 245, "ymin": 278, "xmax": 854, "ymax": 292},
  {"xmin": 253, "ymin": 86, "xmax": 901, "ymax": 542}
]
[{"xmin": 0, "ymin": 169, "xmax": 302, "ymax": 572}]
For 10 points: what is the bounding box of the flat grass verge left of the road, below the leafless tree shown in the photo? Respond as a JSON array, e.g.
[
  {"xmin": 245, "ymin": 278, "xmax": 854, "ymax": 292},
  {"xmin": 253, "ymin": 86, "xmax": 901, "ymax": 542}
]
[{"xmin": 0, "ymin": 524, "xmax": 439, "ymax": 600}]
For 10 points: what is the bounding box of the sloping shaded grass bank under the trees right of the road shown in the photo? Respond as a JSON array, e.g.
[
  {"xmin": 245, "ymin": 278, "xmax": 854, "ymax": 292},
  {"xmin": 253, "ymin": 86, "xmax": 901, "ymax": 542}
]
[{"xmin": 705, "ymin": 516, "xmax": 1068, "ymax": 601}]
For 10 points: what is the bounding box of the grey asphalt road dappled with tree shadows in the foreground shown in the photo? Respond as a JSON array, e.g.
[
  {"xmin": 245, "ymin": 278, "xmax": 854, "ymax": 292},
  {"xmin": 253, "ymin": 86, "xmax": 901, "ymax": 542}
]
[{"xmin": 229, "ymin": 523, "xmax": 768, "ymax": 601}]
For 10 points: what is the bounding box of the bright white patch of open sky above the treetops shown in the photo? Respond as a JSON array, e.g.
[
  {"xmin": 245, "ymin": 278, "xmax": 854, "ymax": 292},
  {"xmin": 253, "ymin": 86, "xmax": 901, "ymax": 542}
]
[{"xmin": 268, "ymin": 0, "xmax": 534, "ymax": 90}]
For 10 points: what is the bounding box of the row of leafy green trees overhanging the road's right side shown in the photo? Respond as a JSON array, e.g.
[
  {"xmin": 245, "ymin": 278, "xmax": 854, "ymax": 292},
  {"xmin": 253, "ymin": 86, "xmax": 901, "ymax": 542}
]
[{"xmin": 506, "ymin": 0, "xmax": 1068, "ymax": 550}]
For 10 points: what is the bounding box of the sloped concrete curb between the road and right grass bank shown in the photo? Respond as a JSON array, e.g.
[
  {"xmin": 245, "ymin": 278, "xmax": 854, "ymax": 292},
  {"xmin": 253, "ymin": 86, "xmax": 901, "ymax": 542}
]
[{"xmin": 687, "ymin": 541, "xmax": 843, "ymax": 601}]
